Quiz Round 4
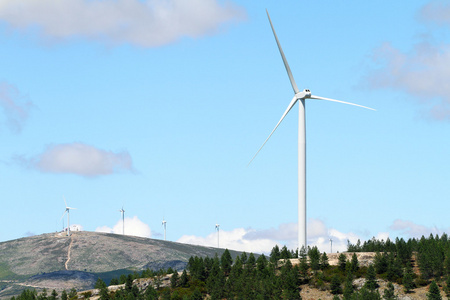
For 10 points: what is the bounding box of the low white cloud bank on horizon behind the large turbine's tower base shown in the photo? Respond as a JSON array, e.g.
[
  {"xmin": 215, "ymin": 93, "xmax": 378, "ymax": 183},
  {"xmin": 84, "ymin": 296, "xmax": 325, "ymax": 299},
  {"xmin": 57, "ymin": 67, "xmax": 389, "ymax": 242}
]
[{"xmin": 177, "ymin": 219, "xmax": 359, "ymax": 254}]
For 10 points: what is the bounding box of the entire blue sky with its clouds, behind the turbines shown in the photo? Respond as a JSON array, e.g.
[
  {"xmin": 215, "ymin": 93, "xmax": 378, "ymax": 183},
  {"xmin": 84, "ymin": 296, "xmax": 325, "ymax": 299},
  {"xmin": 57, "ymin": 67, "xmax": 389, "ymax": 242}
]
[{"xmin": 0, "ymin": 0, "xmax": 450, "ymax": 252}]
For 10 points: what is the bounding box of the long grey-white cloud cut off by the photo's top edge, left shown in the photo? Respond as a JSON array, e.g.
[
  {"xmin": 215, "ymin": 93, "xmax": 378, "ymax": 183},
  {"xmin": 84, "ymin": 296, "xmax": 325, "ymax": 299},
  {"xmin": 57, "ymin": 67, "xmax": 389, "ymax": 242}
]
[{"xmin": 0, "ymin": 0, "xmax": 244, "ymax": 47}]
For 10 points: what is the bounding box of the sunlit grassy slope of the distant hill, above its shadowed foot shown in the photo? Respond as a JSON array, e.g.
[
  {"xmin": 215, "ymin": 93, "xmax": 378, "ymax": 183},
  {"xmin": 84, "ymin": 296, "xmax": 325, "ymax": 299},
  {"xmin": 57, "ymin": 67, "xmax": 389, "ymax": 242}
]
[{"xmin": 0, "ymin": 231, "xmax": 240, "ymax": 280}]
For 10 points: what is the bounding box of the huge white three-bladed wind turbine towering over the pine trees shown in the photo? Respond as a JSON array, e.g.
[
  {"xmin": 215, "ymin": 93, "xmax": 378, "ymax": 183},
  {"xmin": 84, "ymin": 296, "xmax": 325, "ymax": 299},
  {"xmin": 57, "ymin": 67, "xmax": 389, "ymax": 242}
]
[{"xmin": 249, "ymin": 10, "xmax": 375, "ymax": 249}]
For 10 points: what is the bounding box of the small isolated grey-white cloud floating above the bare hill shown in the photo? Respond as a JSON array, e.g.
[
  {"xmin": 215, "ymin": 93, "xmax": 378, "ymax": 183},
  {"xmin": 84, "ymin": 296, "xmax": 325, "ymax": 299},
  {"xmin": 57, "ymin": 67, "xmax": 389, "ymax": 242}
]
[{"xmin": 15, "ymin": 143, "xmax": 133, "ymax": 177}]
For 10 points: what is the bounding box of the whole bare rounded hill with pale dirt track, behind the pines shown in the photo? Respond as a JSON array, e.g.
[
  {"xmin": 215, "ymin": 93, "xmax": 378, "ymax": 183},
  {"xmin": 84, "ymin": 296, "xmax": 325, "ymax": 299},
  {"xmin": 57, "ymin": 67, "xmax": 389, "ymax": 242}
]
[{"xmin": 0, "ymin": 231, "xmax": 240, "ymax": 297}]
